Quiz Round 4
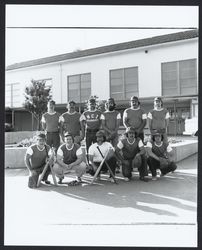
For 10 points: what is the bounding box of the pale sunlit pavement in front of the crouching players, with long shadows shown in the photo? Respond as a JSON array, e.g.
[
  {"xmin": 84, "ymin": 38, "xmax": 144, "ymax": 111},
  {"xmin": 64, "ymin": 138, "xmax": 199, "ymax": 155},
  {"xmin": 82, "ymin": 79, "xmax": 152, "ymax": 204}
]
[{"xmin": 5, "ymin": 155, "xmax": 197, "ymax": 247}]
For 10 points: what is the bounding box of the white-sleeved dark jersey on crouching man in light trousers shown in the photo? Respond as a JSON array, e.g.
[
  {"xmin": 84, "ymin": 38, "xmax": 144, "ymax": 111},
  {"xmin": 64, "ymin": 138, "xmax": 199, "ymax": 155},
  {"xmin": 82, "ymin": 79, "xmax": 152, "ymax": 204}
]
[{"xmin": 57, "ymin": 143, "xmax": 82, "ymax": 164}]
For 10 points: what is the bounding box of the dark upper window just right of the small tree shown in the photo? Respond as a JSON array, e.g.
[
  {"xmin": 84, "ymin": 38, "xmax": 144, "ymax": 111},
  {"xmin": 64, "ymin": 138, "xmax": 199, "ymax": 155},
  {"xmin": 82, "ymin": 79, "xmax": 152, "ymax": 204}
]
[{"xmin": 67, "ymin": 73, "xmax": 91, "ymax": 103}]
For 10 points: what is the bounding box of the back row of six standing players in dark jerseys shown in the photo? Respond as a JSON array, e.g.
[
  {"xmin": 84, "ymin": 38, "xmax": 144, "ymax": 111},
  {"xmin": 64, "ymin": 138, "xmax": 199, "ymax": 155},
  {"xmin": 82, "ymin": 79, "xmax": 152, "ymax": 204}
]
[{"xmin": 42, "ymin": 96, "xmax": 170, "ymax": 151}]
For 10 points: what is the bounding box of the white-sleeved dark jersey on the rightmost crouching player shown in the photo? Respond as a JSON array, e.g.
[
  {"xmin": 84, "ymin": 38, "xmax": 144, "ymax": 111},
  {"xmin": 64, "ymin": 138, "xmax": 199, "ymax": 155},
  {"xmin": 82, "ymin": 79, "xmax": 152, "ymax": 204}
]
[{"xmin": 147, "ymin": 142, "xmax": 172, "ymax": 158}]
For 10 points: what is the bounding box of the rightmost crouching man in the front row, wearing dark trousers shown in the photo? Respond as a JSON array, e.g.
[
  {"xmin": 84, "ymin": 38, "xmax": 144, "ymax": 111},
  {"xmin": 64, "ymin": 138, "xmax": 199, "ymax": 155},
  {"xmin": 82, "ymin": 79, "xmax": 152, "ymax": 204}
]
[{"xmin": 147, "ymin": 132, "xmax": 177, "ymax": 180}]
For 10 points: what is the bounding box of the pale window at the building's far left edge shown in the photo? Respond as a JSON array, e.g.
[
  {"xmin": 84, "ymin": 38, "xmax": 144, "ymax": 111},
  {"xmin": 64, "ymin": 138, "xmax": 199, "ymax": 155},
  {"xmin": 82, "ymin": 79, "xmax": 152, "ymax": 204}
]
[{"xmin": 5, "ymin": 83, "xmax": 21, "ymax": 108}]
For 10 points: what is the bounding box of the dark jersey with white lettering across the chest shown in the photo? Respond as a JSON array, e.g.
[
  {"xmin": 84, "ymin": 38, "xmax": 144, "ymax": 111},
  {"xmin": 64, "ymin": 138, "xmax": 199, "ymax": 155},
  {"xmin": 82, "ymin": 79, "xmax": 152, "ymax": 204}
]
[{"xmin": 80, "ymin": 110, "xmax": 102, "ymax": 130}]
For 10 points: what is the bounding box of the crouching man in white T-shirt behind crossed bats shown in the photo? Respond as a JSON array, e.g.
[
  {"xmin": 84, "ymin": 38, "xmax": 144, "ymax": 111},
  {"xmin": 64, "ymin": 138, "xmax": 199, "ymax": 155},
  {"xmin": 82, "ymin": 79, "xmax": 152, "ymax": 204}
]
[{"xmin": 89, "ymin": 130, "xmax": 116, "ymax": 182}]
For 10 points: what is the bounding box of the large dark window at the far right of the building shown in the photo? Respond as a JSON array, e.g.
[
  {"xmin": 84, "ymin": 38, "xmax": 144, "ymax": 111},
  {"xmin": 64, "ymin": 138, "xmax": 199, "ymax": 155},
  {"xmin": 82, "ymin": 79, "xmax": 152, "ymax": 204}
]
[{"xmin": 162, "ymin": 59, "xmax": 197, "ymax": 96}]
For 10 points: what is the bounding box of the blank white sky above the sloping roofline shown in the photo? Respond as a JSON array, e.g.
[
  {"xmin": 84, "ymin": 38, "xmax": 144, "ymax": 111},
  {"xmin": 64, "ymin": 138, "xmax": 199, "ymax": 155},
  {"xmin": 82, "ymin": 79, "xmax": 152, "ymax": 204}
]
[{"xmin": 5, "ymin": 4, "xmax": 199, "ymax": 66}]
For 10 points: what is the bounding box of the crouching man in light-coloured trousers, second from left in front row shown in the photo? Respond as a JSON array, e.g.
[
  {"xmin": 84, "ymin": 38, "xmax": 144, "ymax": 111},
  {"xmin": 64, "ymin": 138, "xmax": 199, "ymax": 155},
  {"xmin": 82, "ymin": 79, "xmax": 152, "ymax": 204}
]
[{"xmin": 53, "ymin": 132, "xmax": 86, "ymax": 185}]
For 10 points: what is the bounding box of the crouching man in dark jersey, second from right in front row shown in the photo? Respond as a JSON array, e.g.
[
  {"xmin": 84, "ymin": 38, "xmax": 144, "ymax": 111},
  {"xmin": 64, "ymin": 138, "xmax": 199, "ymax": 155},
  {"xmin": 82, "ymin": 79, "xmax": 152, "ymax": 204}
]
[{"xmin": 116, "ymin": 127, "xmax": 148, "ymax": 182}]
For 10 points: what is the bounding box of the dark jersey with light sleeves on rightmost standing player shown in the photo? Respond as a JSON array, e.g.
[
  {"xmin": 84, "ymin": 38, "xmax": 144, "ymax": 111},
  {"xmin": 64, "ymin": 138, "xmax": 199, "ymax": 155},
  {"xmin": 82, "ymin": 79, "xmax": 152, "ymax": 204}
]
[{"xmin": 148, "ymin": 108, "xmax": 170, "ymax": 130}]
